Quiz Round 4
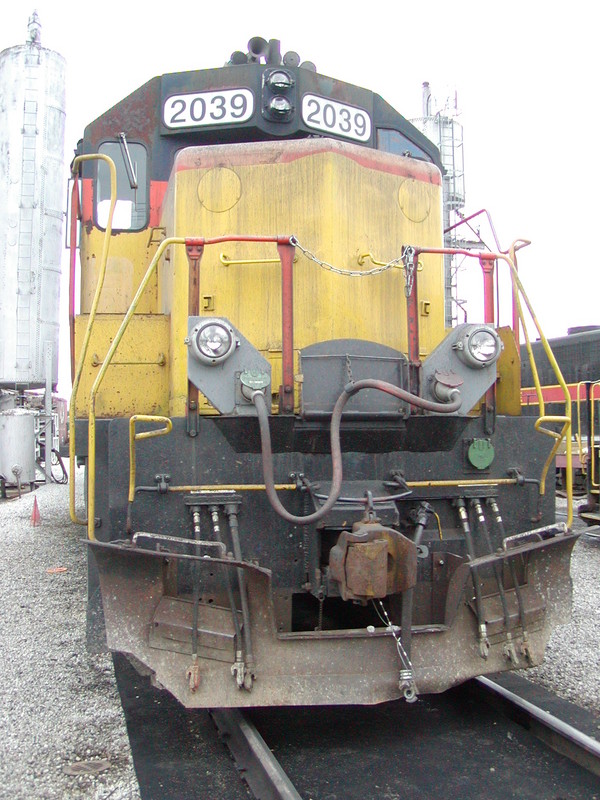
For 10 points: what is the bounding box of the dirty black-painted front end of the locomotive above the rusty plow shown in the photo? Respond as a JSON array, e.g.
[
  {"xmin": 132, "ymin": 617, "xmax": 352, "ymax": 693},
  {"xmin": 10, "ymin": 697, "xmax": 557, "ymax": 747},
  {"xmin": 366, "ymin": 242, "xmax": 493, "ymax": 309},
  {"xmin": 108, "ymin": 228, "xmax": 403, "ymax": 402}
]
[{"xmin": 77, "ymin": 417, "xmax": 554, "ymax": 620}]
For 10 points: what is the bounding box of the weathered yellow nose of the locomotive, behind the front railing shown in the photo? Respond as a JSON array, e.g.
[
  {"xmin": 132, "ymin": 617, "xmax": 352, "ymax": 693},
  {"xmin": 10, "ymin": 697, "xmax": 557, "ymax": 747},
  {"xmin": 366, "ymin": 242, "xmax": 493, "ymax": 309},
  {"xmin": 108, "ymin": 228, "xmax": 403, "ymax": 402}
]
[{"xmin": 158, "ymin": 140, "xmax": 444, "ymax": 414}]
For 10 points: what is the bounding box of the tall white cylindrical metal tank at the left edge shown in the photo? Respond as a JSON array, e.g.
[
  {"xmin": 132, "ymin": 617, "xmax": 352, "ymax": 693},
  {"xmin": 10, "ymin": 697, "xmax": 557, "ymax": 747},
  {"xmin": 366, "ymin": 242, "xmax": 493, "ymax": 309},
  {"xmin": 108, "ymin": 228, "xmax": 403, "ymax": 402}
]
[{"xmin": 0, "ymin": 12, "xmax": 65, "ymax": 389}]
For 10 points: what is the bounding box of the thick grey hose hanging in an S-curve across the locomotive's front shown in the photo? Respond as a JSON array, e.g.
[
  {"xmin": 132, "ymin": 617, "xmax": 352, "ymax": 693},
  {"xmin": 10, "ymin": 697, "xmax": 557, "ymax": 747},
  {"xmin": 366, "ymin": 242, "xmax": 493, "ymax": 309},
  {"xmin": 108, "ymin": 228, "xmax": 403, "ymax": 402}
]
[{"xmin": 252, "ymin": 378, "xmax": 462, "ymax": 525}]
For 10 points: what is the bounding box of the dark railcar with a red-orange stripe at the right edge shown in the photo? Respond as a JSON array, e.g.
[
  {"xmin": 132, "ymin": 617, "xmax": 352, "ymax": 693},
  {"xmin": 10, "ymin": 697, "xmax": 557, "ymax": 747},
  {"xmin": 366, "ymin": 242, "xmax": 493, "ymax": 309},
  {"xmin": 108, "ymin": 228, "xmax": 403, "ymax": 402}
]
[{"xmin": 521, "ymin": 325, "xmax": 600, "ymax": 524}]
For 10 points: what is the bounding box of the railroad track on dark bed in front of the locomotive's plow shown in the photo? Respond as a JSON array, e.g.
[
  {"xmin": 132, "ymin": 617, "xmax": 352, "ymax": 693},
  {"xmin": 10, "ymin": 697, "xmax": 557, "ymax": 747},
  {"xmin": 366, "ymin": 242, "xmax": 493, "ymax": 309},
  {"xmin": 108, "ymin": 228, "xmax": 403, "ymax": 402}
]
[{"xmin": 117, "ymin": 659, "xmax": 600, "ymax": 800}]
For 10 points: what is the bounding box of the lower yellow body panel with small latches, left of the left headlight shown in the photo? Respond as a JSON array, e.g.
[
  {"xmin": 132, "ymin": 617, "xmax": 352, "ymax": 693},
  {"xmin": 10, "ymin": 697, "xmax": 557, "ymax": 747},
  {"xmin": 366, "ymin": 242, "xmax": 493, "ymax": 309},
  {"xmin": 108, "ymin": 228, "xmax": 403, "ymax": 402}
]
[{"xmin": 75, "ymin": 314, "xmax": 170, "ymax": 417}]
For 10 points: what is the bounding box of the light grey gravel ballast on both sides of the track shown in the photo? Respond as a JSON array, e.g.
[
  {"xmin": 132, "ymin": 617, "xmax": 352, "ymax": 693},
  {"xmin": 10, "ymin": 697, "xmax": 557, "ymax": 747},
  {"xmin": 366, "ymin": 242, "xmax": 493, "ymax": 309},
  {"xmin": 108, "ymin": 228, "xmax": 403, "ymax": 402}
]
[{"xmin": 0, "ymin": 478, "xmax": 600, "ymax": 800}]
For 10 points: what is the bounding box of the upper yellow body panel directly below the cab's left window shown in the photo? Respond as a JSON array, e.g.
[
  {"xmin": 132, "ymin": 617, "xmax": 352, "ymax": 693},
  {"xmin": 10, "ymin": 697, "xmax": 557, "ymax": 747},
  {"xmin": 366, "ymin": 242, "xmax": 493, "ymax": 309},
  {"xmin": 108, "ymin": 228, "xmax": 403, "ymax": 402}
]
[{"xmin": 81, "ymin": 228, "xmax": 158, "ymax": 314}]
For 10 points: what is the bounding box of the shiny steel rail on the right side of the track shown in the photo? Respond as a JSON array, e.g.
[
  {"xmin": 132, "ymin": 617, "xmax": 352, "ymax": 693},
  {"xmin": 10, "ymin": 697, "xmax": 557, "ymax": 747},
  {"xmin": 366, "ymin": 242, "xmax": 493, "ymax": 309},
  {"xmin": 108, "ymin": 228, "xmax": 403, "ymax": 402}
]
[{"xmin": 474, "ymin": 677, "xmax": 600, "ymax": 775}]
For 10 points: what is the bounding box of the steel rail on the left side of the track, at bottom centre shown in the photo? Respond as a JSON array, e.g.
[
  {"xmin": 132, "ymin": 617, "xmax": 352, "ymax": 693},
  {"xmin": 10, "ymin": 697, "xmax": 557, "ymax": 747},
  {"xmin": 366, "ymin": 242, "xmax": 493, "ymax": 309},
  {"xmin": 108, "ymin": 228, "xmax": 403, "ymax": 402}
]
[{"xmin": 209, "ymin": 708, "xmax": 302, "ymax": 800}]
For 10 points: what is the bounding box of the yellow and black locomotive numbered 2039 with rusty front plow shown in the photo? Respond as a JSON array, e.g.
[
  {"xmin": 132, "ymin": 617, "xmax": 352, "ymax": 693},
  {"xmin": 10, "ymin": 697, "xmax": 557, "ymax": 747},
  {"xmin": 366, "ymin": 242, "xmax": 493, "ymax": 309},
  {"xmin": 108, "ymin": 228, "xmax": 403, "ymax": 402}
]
[{"xmin": 70, "ymin": 38, "xmax": 576, "ymax": 707}]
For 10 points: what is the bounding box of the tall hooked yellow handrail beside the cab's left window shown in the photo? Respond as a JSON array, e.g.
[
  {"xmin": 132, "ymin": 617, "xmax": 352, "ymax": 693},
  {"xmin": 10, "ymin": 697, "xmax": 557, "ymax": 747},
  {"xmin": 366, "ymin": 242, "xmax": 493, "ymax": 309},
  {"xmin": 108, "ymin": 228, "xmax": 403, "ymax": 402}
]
[{"xmin": 69, "ymin": 153, "xmax": 117, "ymax": 525}]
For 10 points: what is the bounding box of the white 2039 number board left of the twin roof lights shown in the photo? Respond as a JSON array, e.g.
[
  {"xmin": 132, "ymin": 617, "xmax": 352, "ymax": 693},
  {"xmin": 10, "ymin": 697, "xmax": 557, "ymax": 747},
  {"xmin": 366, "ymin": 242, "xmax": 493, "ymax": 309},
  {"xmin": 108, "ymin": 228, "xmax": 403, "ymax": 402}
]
[{"xmin": 163, "ymin": 89, "xmax": 254, "ymax": 128}]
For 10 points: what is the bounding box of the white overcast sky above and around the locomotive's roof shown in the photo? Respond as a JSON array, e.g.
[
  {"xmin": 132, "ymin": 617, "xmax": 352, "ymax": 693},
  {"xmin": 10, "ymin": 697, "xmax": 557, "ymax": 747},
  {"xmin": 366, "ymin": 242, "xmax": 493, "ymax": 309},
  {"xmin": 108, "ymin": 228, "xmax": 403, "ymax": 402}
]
[{"xmin": 0, "ymin": 0, "xmax": 600, "ymax": 392}]
